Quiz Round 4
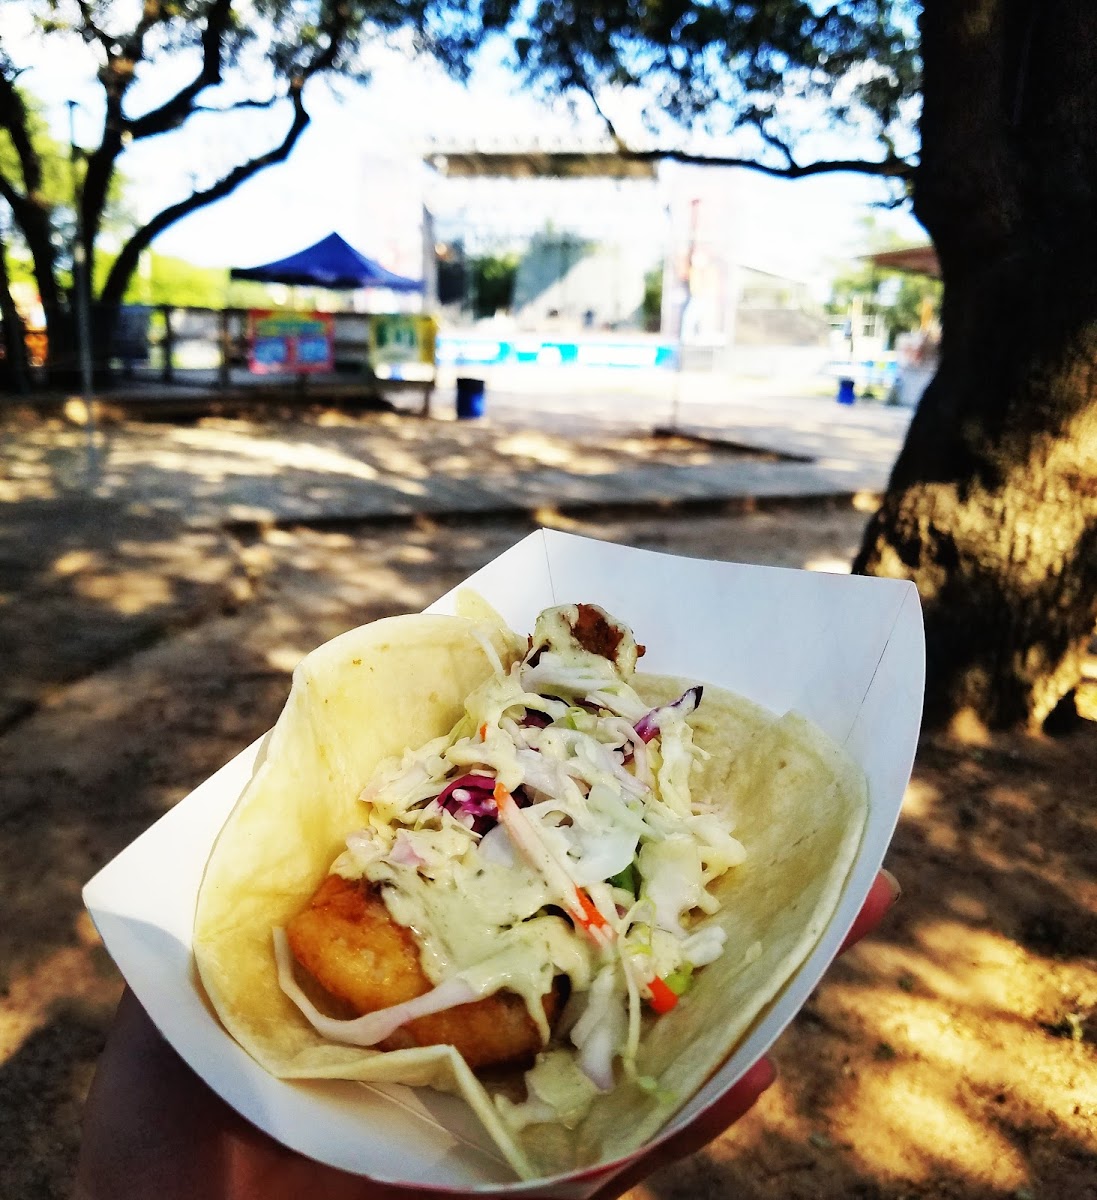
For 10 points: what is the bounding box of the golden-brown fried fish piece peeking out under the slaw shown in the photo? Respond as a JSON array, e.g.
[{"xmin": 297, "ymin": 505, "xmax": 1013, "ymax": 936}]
[{"xmin": 286, "ymin": 875, "xmax": 562, "ymax": 1070}]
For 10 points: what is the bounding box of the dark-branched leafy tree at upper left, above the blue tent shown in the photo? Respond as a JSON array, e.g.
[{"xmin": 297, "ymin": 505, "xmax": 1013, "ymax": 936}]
[{"xmin": 0, "ymin": 0, "xmax": 499, "ymax": 328}]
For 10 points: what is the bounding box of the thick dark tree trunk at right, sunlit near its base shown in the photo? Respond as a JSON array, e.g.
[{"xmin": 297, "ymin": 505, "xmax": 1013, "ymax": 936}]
[{"xmin": 853, "ymin": 0, "xmax": 1097, "ymax": 727}]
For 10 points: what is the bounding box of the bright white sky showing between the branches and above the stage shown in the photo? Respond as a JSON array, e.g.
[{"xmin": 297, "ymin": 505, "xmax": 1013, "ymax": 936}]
[{"xmin": 5, "ymin": 7, "xmax": 924, "ymax": 290}]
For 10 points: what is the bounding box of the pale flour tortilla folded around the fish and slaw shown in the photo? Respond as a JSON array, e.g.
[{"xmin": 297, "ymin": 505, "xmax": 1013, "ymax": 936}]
[{"xmin": 193, "ymin": 616, "xmax": 867, "ymax": 1180}]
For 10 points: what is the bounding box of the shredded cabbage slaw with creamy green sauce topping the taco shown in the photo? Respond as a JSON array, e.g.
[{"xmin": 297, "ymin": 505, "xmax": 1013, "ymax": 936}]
[{"xmin": 276, "ymin": 606, "xmax": 745, "ymax": 1128}]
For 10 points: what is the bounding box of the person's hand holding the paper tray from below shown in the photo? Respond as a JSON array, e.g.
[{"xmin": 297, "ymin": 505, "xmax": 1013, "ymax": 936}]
[{"xmin": 76, "ymin": 871, "xmax": 899, "ymax": 1200}]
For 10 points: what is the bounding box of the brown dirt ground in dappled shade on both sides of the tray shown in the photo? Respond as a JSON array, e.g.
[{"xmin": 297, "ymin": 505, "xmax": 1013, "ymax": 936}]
[{"xmin": 0, "ymin": 408, "xmax": 1097, "ymax": 1200}]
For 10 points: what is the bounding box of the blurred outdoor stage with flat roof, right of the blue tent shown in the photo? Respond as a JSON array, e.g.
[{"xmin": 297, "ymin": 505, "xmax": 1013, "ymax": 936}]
[{"xmin": 422, "ymin": 139, "xmax": 827, "ymax": 370}]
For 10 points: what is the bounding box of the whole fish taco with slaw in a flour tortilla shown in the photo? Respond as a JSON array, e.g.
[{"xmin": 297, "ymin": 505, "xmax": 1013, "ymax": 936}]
[{"xmin": 193, "ymin": 604, "xmax": 867, "ymax": 1178}]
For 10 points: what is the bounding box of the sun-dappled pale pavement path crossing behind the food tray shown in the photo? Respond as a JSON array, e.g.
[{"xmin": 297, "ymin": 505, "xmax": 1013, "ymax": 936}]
[{"xmin": 60, "ymin": 380, "xmax": 911, "ymax": 524}]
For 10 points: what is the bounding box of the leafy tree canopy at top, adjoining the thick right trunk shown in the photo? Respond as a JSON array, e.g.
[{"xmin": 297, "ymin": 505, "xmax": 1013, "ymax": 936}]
[{"xmin": 512, "ymin": 0, "xmax": 921, "ymax": 179}]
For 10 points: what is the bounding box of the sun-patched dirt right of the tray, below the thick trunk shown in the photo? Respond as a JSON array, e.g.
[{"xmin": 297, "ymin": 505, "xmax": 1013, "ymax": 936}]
[{"xmin": 648, "ymin": 731, "xmax": 1097, "ymax": 1200}]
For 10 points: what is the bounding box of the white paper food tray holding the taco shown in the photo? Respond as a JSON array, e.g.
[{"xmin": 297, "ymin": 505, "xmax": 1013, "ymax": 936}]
[{"xmin": 84, "ymin": 529, "xmax": 924, "ymax": 1200}]
